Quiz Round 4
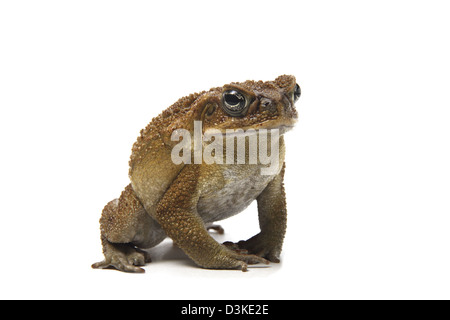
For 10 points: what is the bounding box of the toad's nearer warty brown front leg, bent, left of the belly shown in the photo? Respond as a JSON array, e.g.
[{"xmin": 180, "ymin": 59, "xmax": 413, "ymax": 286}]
[{"xmin": 156, "ymin": 165, "xmax": 268, "ymax": 271}]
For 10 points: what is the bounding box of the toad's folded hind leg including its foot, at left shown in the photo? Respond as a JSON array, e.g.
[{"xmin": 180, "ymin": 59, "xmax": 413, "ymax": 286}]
[{"xmin": 92, "ymin": 185, "xmax": 164, "ymax": 272}]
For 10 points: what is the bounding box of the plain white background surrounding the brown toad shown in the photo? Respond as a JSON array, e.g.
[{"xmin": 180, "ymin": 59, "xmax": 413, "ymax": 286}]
[{"xmin": 0, "ymin": 0, "xmax": 450, "ymax": 299}]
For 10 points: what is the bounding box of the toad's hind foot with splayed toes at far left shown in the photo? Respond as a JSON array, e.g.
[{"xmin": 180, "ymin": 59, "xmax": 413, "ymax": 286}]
[{"xmin": 92, "ymin": 243, "xmax": 151, "ymax": 273}]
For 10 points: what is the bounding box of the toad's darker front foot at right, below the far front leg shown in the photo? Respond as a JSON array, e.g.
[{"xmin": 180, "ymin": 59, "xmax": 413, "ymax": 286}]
[{"xmin": 223, "ymin": 234, "xmax": 281, "ymax": 263}]
